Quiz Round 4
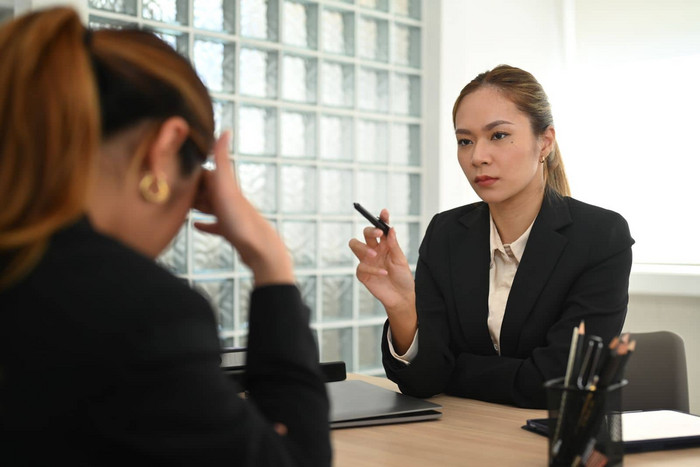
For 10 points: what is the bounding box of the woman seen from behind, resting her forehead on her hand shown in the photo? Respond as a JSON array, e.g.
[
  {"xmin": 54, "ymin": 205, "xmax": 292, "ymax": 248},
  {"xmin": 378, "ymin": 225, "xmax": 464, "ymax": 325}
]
[{"xmin": 0, "ymin": 8, "xmax": 331, "ymax": 466}]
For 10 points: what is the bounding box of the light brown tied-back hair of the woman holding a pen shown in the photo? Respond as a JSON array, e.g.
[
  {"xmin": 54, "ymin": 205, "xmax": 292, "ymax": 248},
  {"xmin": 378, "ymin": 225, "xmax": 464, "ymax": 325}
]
[{"xmin": 452, "ymin": 65, "xmax": 571, "ymax": 196}]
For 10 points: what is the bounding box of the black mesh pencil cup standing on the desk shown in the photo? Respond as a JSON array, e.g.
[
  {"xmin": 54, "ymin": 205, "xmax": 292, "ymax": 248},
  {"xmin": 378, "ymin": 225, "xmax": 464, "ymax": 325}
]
[{"xmin": 545, "ymin": 378, "xmax": 627, "ymax": 467}]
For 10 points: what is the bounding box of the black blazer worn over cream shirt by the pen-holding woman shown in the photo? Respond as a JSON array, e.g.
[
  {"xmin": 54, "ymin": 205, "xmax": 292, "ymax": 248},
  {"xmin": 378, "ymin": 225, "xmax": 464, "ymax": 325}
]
[{"xmin": 382, "ymin": 195, "xmax": 634, "ymax": 408}]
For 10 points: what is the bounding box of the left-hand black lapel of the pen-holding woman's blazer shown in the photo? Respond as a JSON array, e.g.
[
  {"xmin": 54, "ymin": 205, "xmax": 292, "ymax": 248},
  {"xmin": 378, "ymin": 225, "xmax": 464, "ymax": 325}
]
[{"xmin": 449, "ymin": 204, "xmax": 496, "ymax": 355}]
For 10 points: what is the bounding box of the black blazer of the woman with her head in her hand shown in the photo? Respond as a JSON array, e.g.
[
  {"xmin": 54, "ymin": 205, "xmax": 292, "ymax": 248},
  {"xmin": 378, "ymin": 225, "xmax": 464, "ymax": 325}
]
[{"xmin": 0, "ymin": 220, "xmax": 331, "ymax": 466}]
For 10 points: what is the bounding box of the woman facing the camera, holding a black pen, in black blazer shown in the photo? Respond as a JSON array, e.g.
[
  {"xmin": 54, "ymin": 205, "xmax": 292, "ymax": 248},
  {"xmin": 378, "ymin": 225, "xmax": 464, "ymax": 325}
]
[{"xmin": 350, "ymin": 65, "xmax": 634, "ymax": 408}]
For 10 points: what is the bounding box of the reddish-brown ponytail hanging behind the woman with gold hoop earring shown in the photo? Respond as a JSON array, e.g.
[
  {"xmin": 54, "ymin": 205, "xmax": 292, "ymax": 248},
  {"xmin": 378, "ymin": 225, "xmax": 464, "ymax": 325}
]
[{"xmin": 0, "ymin": 8, "xmax": 100, "ymax": 288}]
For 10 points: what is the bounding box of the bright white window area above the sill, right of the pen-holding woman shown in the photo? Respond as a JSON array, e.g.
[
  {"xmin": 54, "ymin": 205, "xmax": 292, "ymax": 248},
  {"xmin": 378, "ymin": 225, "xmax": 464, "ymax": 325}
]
[{"xmin": 555, "ymin": 0, "xmax": 700, "ymax": 266}]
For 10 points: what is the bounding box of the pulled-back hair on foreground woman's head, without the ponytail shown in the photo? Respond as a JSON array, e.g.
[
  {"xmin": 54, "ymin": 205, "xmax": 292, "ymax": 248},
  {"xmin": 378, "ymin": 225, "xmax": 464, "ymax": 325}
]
[{"xmin": 90, "ymin": 29, "xmax": 214, "ymax": 175}]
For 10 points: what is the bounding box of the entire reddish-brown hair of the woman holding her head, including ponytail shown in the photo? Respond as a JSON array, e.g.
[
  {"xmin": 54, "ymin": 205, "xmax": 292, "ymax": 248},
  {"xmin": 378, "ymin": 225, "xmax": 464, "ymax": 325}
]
[{"xmin": 0, "ymin": 8, "xmax": 214, "ymax": 289}]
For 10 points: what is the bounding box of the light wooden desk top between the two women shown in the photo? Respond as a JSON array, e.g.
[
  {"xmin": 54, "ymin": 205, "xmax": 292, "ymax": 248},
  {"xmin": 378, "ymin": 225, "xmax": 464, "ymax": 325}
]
[{"xmin": 331, "ymin": 375, "xmax": 700, "ymax": 467}]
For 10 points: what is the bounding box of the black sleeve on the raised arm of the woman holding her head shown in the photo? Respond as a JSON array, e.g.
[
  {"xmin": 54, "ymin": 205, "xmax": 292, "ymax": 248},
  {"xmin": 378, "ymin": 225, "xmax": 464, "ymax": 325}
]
[{"xmin": 247, "ymin": 286, "xmax": 331, "ymax": 466}]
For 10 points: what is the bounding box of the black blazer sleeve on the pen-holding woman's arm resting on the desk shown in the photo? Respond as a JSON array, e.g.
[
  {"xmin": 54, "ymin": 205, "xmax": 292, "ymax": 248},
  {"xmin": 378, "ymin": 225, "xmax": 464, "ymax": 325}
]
[{"xmin": 445, "ymin": 210, "xmax": 633, "ymax": 408}]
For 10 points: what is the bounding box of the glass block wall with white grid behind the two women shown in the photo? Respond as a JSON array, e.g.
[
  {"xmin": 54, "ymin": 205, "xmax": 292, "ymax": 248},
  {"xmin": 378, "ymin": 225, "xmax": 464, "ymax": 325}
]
[{"xmin": 83, "ymin": 0, "xmax": 423, "ymax": 374}]
